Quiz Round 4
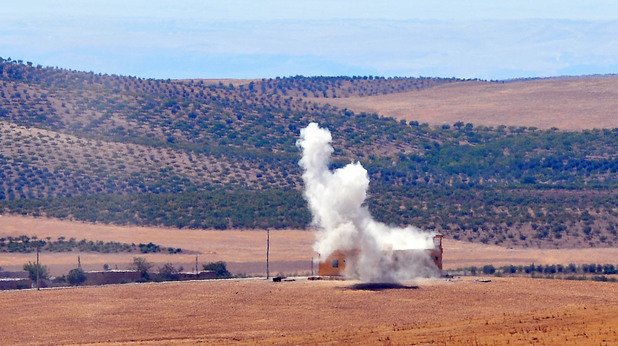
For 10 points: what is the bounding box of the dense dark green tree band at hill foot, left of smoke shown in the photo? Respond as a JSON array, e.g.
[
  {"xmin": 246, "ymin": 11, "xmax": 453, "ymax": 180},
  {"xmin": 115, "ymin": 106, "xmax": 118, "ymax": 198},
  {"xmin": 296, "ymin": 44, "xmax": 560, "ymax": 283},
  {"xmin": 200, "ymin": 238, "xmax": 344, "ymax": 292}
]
[{"xmin": 0, "ymin": 187, "xmax": 310, "ymax": 229}]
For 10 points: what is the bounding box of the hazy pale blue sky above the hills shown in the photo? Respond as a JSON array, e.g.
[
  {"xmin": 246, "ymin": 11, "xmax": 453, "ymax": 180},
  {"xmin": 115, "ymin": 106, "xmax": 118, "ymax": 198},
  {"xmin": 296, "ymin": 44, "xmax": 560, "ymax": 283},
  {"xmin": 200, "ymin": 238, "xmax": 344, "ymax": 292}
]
[{"xmin": 0, "ymin": 0, "xmax": 618, "ymax": 79}]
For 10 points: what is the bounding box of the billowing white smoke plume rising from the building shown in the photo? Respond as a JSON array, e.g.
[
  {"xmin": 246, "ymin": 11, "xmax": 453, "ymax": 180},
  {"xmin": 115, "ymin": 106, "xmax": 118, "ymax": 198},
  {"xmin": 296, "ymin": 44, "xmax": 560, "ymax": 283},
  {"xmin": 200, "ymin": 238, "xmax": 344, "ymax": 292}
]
[{"xmin": 297, "ymin": 123, "xmax": 438, "ymax": 282}]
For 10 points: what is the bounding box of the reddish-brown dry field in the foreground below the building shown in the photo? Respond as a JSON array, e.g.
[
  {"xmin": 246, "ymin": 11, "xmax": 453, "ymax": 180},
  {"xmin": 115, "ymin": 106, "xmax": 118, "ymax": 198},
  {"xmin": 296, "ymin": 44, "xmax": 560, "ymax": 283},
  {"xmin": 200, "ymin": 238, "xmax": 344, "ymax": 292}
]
[{"xmin": 0, "ymin": 278, "xmax": 618, "ymax": 345}]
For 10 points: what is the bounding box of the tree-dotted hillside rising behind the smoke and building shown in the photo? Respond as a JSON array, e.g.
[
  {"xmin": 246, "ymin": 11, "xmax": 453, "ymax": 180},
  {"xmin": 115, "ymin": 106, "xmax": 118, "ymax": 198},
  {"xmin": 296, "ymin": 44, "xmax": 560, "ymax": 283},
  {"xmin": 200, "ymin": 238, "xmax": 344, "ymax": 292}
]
[{"xmin": 0, "ymin": 59, "xmax": 618, "ymax": 247}]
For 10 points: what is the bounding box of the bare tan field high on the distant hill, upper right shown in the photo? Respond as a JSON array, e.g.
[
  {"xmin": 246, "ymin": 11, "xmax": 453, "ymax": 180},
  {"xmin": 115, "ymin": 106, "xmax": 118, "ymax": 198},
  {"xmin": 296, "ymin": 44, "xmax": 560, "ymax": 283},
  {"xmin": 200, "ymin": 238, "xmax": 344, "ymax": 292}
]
[{"xmin": 312, "ymin": 76, "xmax": 618, "ymax": 130}]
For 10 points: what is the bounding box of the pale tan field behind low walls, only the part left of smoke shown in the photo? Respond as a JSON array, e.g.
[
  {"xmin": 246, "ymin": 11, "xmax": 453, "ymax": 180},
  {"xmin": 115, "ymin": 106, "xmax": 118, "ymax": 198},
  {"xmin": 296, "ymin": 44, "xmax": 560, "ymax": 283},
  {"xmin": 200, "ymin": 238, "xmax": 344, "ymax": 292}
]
[{"xmin": 0, "ymin": 215, "xmax": 313, "ymax": 274}]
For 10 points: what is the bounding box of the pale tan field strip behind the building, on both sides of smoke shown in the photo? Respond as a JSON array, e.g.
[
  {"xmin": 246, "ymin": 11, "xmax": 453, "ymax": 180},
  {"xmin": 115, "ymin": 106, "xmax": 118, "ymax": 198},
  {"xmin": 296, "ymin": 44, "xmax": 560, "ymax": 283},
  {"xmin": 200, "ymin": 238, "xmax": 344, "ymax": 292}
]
[{"xmin": 0, "ymin": 215, "xmax": 618, "ymax": 274}]
